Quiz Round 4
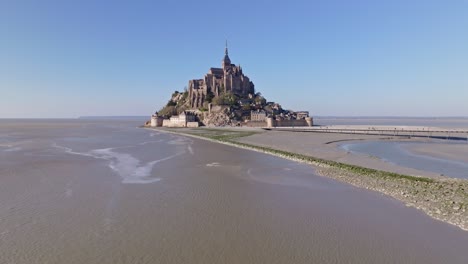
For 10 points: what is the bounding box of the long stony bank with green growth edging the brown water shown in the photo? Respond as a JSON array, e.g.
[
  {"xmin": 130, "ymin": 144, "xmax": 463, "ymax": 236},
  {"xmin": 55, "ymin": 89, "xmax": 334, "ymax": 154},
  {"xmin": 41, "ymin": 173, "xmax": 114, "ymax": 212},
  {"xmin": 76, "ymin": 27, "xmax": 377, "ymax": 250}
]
[{"xmin": 148, "ymin": 128, "xmax": 468, "ymax": 231}]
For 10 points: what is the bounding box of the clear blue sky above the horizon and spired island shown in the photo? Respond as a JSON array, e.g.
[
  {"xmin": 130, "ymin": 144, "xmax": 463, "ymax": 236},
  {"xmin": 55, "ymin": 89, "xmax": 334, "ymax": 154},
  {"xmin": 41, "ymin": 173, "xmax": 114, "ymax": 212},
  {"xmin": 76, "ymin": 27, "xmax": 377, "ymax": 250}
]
[{"xmin": 0, "ymin": 0, "xmax": 468, "ymax": 118}]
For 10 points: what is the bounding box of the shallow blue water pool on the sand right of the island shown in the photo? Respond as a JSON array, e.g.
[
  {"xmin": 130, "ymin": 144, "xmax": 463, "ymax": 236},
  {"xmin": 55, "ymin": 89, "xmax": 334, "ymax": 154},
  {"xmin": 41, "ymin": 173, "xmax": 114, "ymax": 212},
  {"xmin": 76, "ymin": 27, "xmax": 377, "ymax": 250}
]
[{"xmin": 339, "ymin": 141, "xmax": 468, "ymax": 179}]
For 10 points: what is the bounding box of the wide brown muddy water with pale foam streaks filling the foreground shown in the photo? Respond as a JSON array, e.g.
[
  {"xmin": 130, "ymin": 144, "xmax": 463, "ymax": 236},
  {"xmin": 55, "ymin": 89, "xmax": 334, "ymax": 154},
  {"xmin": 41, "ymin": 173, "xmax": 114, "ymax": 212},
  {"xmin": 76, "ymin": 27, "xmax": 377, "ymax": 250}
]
[{"xmin": 0, "ymin": 120, "xmax": 468, "ymax": 263}]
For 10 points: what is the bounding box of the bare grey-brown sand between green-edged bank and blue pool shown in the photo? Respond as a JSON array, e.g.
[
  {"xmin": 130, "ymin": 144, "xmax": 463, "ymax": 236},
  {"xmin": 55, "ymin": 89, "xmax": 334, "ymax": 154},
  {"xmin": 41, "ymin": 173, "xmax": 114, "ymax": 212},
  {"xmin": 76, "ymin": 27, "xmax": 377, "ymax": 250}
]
[{"xmin": 239, "ymin": 131, "xmax": 439, "ymax": 177}]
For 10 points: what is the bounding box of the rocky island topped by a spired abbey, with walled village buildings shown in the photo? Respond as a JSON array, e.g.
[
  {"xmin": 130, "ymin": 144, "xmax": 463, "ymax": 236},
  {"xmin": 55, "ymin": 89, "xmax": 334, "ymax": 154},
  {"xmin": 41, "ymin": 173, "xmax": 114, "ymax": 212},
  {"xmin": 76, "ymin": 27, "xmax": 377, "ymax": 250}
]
[{"xmin": 146, "ymin": 44, "xmax": 313, "ymax": 127}]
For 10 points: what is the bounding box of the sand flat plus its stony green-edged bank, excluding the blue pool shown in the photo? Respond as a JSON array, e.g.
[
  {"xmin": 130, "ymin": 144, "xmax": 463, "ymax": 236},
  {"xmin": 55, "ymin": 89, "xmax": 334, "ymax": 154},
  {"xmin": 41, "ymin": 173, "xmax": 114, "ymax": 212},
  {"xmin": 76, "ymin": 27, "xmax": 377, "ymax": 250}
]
[{"xmin": 160, "ymin": 128, "xmax": 468, "ymax": 231}]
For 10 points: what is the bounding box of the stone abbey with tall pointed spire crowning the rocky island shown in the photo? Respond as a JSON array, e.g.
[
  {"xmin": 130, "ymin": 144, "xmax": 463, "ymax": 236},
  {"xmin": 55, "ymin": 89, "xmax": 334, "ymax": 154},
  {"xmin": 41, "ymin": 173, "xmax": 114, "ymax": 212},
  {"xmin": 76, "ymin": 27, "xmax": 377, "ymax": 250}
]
[{"xmin": 188, "ymin": 45, "xmax": 255, "ymax": 108}]
